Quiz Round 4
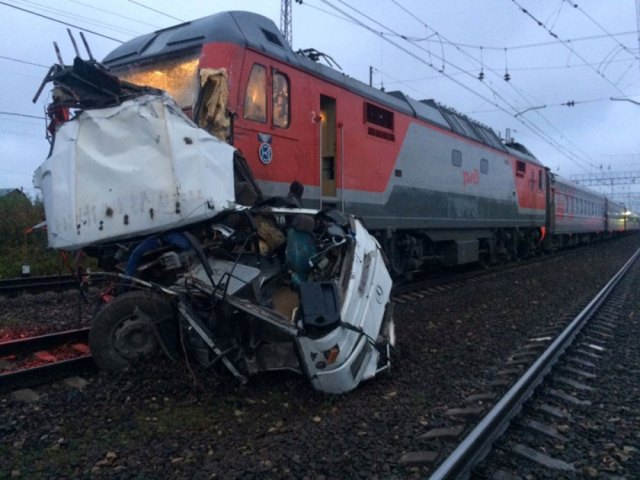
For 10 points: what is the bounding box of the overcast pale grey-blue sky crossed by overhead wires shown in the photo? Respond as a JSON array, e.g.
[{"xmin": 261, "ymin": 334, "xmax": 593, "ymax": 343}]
[{"xmin": 0, "ymin": 0, "xmax": 640, "ymax": 202}]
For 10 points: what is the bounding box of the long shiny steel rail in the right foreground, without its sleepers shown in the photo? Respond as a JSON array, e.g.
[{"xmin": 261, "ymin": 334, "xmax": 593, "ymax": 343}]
[{"xmin": 429, "ymin": 249, "xmax": 640, "ymax": 480}]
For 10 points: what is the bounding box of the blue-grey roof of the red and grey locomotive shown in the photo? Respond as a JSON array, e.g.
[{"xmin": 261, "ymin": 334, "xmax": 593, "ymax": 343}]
[{"xmin": 102, "ymin": 11, "xmax": 508, "ymax": 154}]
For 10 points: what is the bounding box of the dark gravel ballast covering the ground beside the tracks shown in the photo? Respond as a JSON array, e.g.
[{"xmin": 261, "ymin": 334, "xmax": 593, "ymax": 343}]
[{"xmin": 0, "ymin": 235, "xmax": 640, "ymax": 480}]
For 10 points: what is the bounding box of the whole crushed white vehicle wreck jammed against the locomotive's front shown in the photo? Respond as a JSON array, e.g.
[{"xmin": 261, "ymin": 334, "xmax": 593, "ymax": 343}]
[{"xmin": 34, "ymin": 58, "xmax": 394, "ymax": 393}]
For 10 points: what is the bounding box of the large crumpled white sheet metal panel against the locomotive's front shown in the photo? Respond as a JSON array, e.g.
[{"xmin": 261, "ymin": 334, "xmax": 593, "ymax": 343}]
[{"xmin": 34, "ymin": 95, "xmax": 235, "ymax": 249}]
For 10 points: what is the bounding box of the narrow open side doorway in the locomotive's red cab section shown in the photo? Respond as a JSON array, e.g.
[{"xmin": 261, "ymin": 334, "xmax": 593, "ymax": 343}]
[{"xmin": 319, "ymin": 95, "xmax": 337, "ymax": 208}]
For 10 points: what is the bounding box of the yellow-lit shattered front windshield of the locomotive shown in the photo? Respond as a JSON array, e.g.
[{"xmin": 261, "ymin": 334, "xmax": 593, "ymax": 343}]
[{"xmin": 115, "ymin": 57, "xmax": 198, "ymax": 108}]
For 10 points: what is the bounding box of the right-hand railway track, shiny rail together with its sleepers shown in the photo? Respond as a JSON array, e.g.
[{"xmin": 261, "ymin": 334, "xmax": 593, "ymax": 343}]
[{"xmin": 400, "ymin": 246, "xmax": 640, "ymax": 480}]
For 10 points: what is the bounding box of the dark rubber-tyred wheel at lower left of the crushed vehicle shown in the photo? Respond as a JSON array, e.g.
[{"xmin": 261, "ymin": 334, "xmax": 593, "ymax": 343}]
[{"xmin": 89, "ymin": 291, "xmax": 175, "ymax": 371}]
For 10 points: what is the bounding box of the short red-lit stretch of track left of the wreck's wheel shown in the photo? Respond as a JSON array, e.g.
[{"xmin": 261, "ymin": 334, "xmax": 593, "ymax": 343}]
[{"xmin": 0, "ymin": 328, "xmax": 96, "ymax": 393}]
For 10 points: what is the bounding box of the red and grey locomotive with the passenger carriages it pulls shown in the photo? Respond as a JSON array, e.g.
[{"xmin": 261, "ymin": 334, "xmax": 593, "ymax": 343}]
[{"xmin": 103, "ymin": 12, "xmax": 626, "ymax": 273}]
